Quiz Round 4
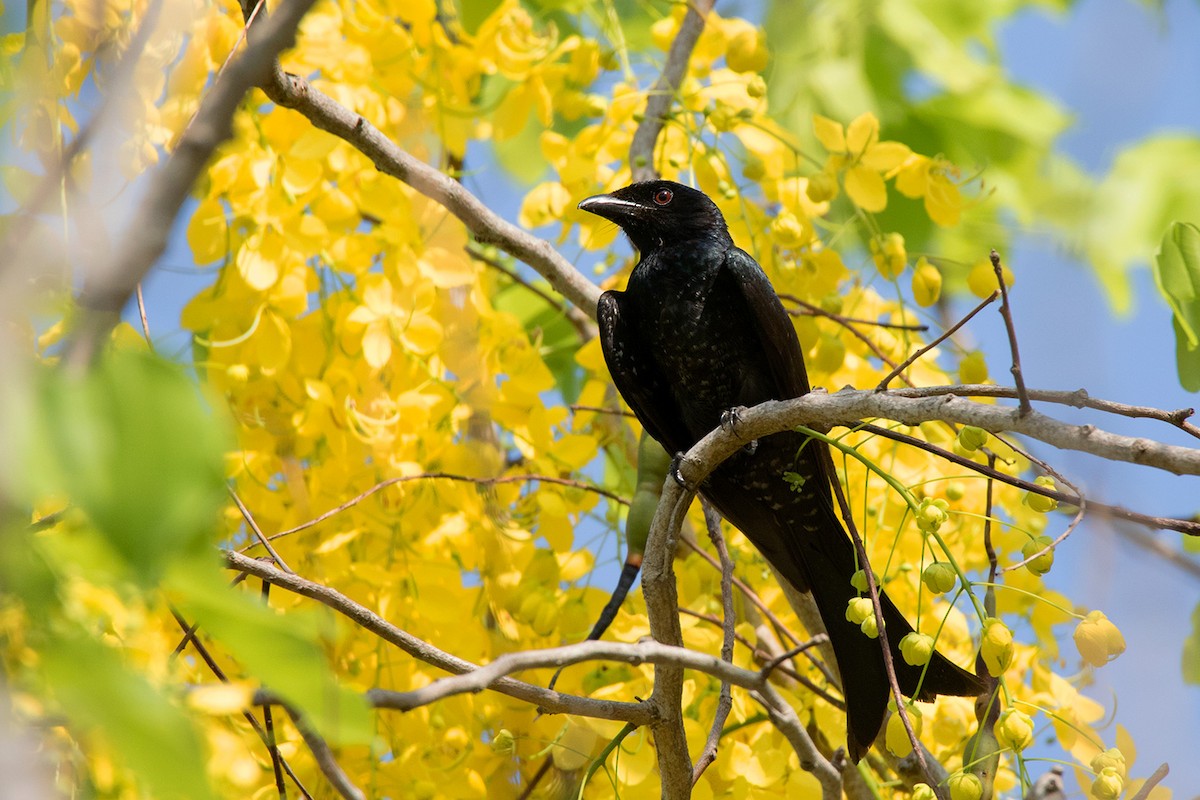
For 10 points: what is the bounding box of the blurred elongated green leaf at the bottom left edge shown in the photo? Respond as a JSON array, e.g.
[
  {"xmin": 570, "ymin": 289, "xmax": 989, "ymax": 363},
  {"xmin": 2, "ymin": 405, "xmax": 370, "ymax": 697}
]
[{"xmin": 41, "ymin": 636, "xmax": 214, "ymax": 800}]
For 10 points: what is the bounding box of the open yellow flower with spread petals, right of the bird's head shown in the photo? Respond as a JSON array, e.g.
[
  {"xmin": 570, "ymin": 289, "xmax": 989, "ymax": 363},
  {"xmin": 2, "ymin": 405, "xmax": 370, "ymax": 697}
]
[{"xmin": 812, "ymin": 112, "xmax": 912, "ymax": 212}]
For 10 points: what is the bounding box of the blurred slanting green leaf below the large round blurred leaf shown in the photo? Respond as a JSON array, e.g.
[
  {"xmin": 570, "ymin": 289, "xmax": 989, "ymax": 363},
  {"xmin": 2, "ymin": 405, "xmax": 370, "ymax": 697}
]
[{"xmin": 168, "ymin": 564, "xmax": 372, "ymax": 744}]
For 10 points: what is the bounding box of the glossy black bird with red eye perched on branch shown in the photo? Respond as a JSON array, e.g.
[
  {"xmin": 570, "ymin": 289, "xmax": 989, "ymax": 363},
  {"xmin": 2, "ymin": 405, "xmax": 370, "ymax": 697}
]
[{"xmin": 580, "ymin": 180, "xmax": 984, "ymax": 762}]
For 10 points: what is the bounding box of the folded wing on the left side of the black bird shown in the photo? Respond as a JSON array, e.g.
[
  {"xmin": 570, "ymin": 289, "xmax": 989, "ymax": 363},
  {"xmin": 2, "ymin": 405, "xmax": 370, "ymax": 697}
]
[{"xmin": 596, "ymin": 291, "xmax": 692, "ymax": 453}]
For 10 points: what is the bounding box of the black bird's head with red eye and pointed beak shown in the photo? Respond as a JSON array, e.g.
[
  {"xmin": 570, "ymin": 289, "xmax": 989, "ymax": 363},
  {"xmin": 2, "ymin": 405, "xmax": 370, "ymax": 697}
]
[{"xmin": 580, "ymin": 181, "xmax": 732, "ymax": 257}]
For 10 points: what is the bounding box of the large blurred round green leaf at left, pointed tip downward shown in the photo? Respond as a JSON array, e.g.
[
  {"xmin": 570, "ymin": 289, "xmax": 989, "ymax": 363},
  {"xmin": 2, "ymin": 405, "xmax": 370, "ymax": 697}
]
[{"xmin": 14, "ymin": 351, "xmax": 227, "ymax": 582}]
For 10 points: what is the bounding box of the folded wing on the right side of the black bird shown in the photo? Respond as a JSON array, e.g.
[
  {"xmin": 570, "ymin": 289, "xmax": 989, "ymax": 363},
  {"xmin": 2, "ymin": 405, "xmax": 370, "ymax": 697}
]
[{"xmin": 724, "ymin": 247, "xmax": 809, "ymax": 399}]
